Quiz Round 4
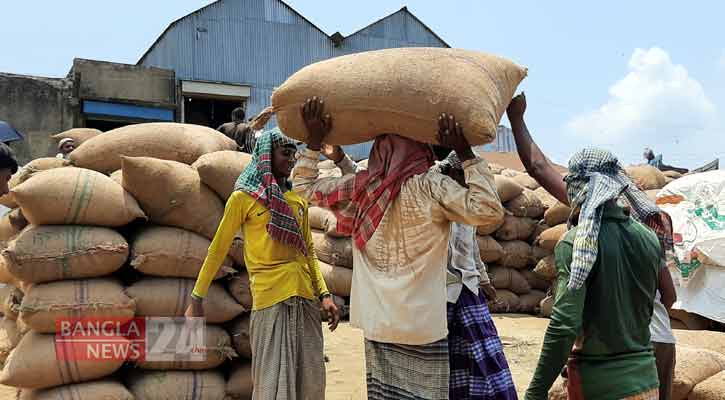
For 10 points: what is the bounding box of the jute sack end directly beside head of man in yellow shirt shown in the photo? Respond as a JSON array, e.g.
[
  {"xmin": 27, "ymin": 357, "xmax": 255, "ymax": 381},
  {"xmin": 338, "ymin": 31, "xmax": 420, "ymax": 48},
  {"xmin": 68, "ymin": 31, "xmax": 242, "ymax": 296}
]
[{"xmin": 191, "ymin": 150, "xmax": 252, "ymax": 200}]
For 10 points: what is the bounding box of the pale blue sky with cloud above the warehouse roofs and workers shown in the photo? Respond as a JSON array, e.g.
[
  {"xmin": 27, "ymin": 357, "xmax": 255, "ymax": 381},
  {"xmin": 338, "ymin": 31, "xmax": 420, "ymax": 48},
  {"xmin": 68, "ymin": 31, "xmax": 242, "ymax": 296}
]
[{"xmin": 0, "ymin": 0, "xmax": 725, "ymax": 167}]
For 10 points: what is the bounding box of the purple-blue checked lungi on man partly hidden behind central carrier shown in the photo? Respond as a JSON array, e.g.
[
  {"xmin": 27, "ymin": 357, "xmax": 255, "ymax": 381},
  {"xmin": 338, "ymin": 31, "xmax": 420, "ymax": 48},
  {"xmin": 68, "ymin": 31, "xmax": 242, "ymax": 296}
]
[{"xmin": 448, "ymin": 287, "xmax": 518, "ymax": 400}]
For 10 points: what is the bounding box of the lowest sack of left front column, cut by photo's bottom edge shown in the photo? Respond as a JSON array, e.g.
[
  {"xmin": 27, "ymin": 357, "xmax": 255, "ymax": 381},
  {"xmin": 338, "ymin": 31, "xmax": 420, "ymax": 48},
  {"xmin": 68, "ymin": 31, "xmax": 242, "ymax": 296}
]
[{"xmin": 17, "ymin": 379, "xmax": 135, "ymax": 400}]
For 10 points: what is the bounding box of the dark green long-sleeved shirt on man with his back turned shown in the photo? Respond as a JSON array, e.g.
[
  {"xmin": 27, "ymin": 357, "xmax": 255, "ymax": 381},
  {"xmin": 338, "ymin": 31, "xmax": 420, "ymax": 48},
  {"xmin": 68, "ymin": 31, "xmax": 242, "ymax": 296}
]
[{"xmin": 526, "ymin": 205, "xmax": 660, "ymax": 400}]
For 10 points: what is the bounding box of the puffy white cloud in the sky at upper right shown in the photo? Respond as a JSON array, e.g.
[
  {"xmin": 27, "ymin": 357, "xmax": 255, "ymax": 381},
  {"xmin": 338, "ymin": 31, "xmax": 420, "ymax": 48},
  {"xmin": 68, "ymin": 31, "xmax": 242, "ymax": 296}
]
[{"xmin": 567, "ymin": 47, "xmax": 725, "ymax": 155}]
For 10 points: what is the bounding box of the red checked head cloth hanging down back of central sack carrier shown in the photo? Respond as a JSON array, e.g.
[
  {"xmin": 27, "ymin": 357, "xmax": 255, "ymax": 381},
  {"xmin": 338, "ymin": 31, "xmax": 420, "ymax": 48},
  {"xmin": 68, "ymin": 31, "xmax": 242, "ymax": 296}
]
[{"xmin": 316, "ymin": 134, "xmax": 434, "ymax": 249}]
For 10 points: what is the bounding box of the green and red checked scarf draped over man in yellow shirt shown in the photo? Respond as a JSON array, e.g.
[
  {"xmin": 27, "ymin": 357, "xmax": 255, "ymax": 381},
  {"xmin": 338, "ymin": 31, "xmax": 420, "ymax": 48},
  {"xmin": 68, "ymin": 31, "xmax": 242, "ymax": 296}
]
[{"xmin": 234, "ymin": 128, "xmax": 307, "ymax": 256}]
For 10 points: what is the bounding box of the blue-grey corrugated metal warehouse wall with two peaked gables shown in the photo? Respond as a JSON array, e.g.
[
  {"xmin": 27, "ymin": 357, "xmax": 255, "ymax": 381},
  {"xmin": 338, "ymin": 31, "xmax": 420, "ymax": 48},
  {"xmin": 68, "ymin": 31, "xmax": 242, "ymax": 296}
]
[{"xmin": 140, "ymin": 0, "xmax": 445, "ymax": 158}]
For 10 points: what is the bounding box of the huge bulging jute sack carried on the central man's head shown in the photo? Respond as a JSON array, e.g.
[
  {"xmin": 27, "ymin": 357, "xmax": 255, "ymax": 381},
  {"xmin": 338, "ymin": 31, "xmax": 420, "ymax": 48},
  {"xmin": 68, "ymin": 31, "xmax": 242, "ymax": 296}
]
[{"xmin": 253, "ymin": 47, "xmax": 526, "ymax": 145}]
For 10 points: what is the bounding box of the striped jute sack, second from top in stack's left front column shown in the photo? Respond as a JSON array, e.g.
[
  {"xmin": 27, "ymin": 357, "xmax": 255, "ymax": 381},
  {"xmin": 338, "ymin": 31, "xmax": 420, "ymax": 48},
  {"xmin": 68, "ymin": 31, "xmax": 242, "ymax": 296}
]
[{"xmin": 2, "ymin": 225, "xmax": 128, "ymax": 283}]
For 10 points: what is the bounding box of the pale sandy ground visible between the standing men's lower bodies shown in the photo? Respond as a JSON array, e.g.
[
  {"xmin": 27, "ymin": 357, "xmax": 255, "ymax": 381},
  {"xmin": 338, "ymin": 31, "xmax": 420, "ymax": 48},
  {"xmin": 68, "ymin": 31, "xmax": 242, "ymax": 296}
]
[{"xmin": 325, "ymin": 314, "xmax": 549, "ymax": 400}]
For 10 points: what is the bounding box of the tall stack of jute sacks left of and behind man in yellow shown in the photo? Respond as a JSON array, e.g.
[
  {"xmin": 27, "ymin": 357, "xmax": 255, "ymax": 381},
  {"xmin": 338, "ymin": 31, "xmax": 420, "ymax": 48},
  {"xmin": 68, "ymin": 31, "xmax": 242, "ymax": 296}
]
[{"xmin": 0, "ymin": 123, "xmax": 288, "ymax": 399}]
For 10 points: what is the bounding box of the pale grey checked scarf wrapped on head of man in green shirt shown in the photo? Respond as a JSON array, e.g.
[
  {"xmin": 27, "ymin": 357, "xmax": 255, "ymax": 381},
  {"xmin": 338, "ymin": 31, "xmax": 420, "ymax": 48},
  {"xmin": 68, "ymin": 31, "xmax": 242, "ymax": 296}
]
[{"xmin": 564, "ymin": 148, "xmax": 672, "ymax": 290}]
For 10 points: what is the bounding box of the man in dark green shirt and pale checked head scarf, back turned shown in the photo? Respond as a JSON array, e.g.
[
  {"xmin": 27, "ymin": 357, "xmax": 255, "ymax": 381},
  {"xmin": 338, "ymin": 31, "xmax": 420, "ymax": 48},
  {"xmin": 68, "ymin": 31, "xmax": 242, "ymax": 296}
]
[{"xmin": 526, "ymin": 149, "xmax": 661, "ymax": 400}]
